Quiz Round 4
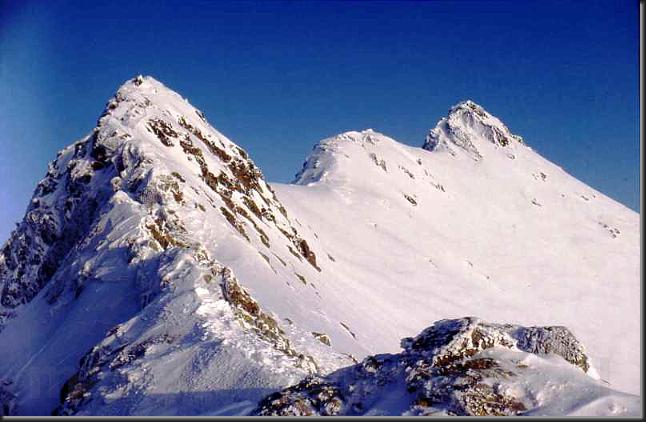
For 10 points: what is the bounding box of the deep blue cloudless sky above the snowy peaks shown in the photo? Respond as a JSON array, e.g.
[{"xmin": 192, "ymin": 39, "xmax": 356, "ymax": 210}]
[{"xmin": 0, "ymin": 0, "xmax": 639, "ymax": 241}]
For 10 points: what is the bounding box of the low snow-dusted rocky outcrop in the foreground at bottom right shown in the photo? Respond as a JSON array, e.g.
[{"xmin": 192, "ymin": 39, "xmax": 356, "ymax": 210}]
[{"xmin": 255, "ymin": 317, "xmax": 638, "ymax": 416}]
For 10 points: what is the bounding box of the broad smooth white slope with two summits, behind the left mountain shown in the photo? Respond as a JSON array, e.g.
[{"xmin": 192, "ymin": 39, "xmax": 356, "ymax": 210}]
[{"xmin": 274, "ymin": 101, "xmax": 640, "ymax": 393}]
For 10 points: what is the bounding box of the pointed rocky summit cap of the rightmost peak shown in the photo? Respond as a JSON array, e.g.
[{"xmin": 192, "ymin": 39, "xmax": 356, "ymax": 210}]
[{"xmin": 422, "ymin": 100, "xmax": 524, "ymax": 160}]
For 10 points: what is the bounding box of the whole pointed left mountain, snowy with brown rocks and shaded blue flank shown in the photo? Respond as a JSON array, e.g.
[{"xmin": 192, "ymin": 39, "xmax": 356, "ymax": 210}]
[{"xmin": 0, "ymin": 77, "xmax": 351, "ymax": 415}]
